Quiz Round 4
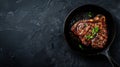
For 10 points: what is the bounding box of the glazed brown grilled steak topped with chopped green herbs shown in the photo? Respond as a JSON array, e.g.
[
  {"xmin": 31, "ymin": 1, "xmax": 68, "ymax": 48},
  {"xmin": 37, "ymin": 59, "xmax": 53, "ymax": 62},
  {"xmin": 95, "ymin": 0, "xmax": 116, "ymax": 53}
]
[{"xmin": 71, "ymin": 14, "xmax": 108, "ymax": 48}]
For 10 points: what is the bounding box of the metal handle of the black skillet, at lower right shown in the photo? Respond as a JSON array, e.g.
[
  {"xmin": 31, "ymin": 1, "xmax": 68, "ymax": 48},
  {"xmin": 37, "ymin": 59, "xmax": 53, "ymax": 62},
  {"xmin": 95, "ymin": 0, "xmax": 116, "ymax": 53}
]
[{"xmin": 101, "ymin": 49, "xmax": 120, "ymax": 67}]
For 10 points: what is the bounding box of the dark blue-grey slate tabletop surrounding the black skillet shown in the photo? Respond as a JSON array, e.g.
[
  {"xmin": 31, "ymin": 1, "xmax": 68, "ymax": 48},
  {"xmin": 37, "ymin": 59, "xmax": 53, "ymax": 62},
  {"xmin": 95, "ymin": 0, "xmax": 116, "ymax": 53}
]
[{"xmin": 0, "ymin": 0, "xmax": 120, "ymax": 67}]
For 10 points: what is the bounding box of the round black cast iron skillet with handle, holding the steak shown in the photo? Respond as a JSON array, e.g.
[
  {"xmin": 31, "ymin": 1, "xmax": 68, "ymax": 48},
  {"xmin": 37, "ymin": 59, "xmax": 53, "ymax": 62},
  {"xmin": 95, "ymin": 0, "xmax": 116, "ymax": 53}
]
[{"xmin": 64, "ymin": 4, "xmax": 119, "ymax": 67}]
